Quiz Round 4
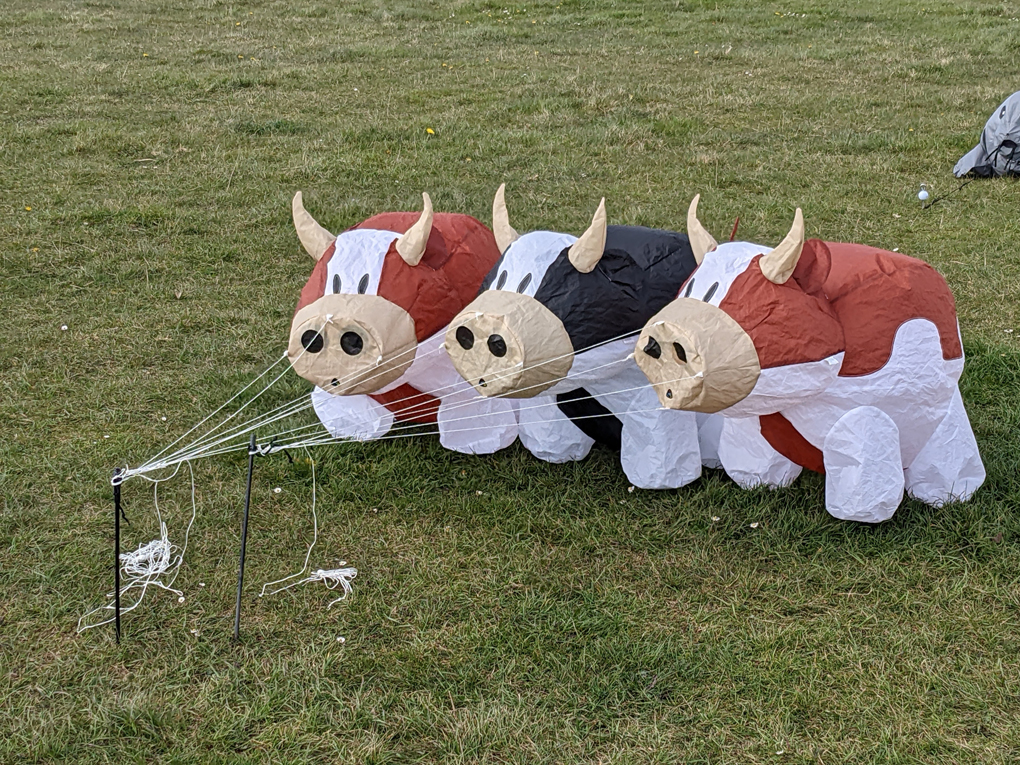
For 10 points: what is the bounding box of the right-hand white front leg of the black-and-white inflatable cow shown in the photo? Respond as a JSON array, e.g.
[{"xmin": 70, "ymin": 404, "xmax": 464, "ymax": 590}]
[{"xmin": 617, "ymin": 408, "xmax": 702, "ymax": 489}]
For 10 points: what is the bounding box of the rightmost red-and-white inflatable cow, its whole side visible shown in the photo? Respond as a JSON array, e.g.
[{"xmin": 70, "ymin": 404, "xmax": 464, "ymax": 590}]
[{"xmin": 635, "ymin": 197, "xmax": 984, "ymax": 522}]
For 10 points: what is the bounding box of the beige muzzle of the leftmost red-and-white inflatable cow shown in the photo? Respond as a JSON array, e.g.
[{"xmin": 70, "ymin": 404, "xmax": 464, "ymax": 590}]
[{"xmin": 287, "ymin": 295, "xmax": 418, "ymax": 396}]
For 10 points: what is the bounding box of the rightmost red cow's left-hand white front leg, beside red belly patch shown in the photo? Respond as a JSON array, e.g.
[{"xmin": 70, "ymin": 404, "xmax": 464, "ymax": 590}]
[{"xmin": 718, "ymin": 417, "xmax": 803, "ymax": 489}]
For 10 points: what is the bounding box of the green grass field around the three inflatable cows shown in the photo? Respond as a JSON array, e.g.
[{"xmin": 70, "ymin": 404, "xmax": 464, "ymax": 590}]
[{"xmin": 0, "ymin": 0, "xmax": 1020, "ymax": 765}]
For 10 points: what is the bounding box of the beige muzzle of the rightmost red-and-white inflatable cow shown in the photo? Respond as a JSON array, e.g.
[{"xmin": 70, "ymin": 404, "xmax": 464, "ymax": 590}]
[{"xmin": 634, "ymin": 298, "xmax": 761, "ymax": 413}]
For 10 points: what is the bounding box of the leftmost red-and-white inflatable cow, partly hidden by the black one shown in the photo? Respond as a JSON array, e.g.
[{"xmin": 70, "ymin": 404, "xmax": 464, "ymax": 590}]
[{"xmin": 288, "ymin": 192, "xmax": 516, "ymax": 454}]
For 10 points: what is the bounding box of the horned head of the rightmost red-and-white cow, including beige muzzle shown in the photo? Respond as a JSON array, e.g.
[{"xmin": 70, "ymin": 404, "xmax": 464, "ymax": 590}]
[{"xmin": 634, "ymin": 195, "xmax": 844, "ymax": 413}]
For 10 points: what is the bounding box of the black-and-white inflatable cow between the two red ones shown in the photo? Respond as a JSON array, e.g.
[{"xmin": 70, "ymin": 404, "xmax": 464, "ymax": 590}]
[{"xmin": 438, "ymin": 187, "xmax": 701, "ymax": 489}]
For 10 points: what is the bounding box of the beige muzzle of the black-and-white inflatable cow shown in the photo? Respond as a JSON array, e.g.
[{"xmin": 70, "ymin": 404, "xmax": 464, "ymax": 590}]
[{"xmin": 446, "ymin": 290, "xmax": 573, "ymax": 399}]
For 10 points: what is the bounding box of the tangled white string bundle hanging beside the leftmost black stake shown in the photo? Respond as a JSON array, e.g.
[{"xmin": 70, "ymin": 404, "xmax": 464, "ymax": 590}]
[{"xmin": 78, "ymin": 462, "xmax": 197, "ymax": 634}]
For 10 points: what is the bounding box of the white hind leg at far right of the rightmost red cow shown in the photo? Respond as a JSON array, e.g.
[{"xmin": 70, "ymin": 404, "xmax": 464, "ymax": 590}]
[{"xmin": 906, "ymin": 388, "xmax": 984, "ymax": 507}]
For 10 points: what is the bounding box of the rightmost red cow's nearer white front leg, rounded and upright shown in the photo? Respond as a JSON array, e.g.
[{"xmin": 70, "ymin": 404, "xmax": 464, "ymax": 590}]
[{"xmin": 822, "ymin": 406, "xmax": 904, "ymax": 523}]
